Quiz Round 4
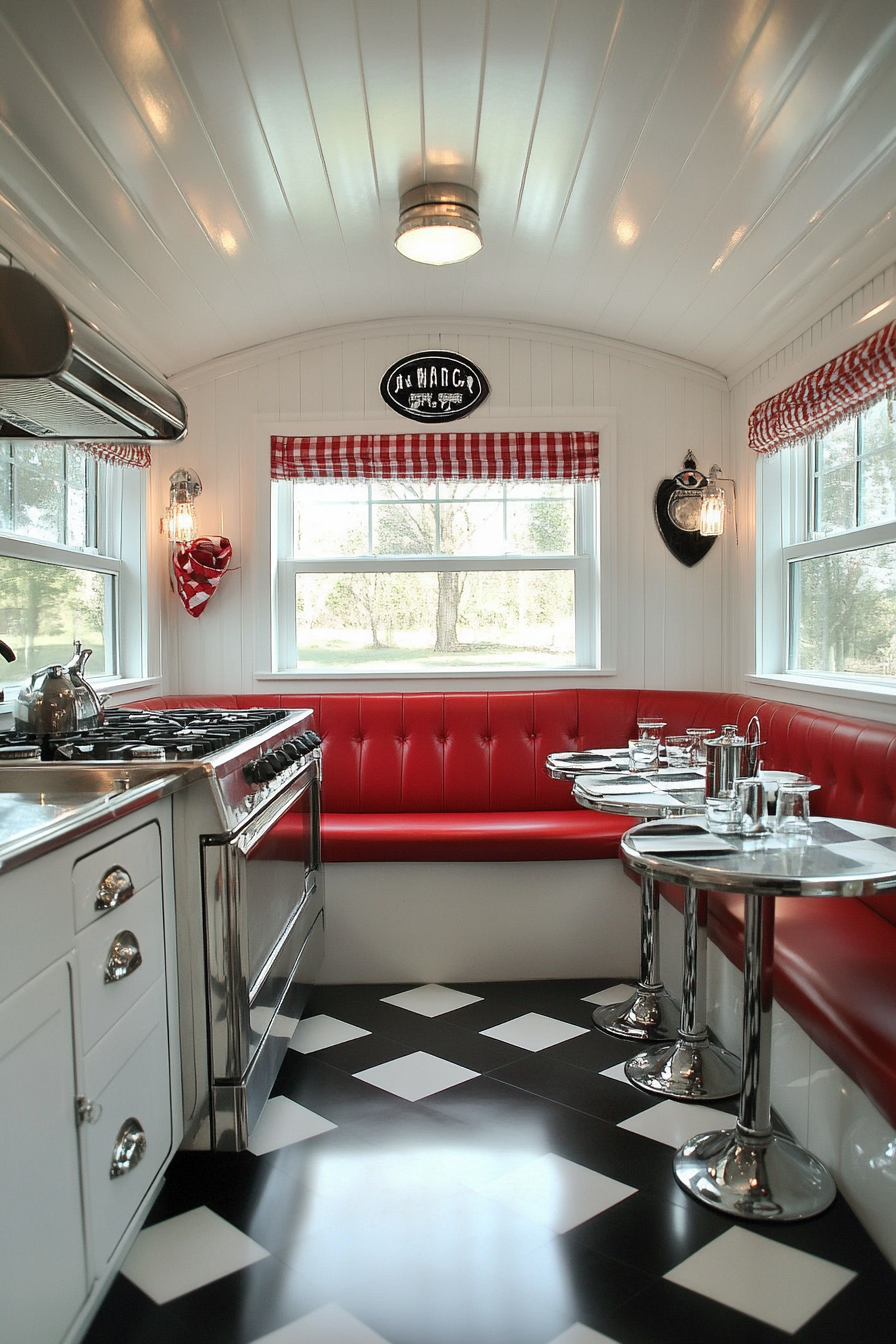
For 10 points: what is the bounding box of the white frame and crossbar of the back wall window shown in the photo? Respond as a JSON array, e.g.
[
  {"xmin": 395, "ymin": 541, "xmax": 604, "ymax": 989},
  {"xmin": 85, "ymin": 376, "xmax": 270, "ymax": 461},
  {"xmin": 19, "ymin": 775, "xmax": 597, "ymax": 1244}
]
[{"xmin": 270, "ymin": 478, "xmax": 603, "ymax": 677}]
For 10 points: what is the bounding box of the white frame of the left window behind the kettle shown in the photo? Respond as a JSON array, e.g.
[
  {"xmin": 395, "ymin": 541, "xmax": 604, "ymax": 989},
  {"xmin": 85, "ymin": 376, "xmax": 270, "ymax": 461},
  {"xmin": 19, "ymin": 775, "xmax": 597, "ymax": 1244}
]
[{"xmin": 0, "ymin": 441, "xmax": 149, "ymax": 712}]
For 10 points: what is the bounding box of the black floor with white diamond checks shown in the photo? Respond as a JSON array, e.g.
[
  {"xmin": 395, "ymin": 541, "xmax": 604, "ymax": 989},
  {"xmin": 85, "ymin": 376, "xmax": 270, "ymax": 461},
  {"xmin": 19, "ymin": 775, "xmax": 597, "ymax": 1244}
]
[{"xmin": 87, "ymin": 981, "xmax": 896, "ymax": 1344}]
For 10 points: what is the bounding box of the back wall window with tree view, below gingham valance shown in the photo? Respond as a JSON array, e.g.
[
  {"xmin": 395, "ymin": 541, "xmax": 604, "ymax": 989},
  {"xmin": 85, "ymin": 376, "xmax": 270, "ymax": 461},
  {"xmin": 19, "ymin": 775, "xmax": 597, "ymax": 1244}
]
[{"xmin": 274, "ymin": 480, "xmax": 598, "ymax": 672}]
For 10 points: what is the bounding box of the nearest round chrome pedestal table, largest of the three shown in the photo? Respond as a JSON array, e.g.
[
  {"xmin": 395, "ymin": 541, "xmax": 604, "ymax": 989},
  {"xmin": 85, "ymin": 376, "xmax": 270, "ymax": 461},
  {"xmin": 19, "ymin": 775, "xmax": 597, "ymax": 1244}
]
[{"xmin": 622, "ymin": 818, "xmax": 896, "ymax": 1222}]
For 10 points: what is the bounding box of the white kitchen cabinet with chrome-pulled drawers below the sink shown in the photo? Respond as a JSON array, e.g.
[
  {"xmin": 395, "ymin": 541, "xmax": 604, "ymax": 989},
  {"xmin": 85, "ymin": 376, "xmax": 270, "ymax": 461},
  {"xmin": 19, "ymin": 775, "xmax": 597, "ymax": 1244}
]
[{"xmin": 0, "ymin": 800, "xmax": 183, "ymax": 1344}]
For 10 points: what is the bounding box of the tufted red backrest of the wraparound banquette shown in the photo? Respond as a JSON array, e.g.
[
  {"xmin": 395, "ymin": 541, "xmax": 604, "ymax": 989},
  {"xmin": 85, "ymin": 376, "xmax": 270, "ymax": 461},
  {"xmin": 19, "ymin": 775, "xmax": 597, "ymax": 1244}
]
[{"xmin": 124, "ymin": 688, "xmax": 896, "ymax": 849}]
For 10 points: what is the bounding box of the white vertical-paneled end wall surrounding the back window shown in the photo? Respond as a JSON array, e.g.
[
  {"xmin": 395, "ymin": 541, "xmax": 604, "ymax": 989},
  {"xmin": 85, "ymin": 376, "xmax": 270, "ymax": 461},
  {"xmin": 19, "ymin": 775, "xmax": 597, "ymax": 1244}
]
[{"xmin": 165, "ymin": 320, "xmax": 727, "ymax": 692}]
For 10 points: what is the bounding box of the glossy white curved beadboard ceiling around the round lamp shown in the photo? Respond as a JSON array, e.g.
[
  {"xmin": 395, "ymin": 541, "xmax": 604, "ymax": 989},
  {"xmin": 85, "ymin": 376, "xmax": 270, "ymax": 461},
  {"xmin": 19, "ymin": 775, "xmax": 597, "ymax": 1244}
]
[{"xmin": 0, "ymin": 0, "xmax": 896, "ymax": 375}]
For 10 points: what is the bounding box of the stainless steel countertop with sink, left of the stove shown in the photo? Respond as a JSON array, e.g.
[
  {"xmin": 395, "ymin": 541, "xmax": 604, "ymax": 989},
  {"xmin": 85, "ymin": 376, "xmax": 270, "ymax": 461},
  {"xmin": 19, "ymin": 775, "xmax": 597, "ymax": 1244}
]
[{"xmin": 0, "ymin": 762, "xmax": 201, "ymax": 874}]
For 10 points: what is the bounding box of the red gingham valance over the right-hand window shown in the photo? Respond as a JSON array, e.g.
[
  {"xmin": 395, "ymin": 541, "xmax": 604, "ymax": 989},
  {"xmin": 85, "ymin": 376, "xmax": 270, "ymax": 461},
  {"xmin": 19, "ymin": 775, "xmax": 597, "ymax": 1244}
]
[{"xmin": 750, "ymin": 323, "xmax": 896, "ymax": 453}]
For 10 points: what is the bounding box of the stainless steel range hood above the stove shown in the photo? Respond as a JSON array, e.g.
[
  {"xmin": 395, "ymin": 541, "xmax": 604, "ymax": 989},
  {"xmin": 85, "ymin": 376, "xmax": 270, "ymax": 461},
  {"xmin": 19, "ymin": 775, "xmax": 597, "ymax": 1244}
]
[{"xmin": 0, "ymin": 266, "xmax": 187, "ymax": 444}]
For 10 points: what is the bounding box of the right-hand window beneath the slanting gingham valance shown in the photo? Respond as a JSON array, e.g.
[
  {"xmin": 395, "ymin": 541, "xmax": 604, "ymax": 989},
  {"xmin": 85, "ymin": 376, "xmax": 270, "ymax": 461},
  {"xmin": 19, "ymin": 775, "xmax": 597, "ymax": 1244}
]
[{"xmin": 782, "ymin": 396, "xmax": 896, "ymax": 679}]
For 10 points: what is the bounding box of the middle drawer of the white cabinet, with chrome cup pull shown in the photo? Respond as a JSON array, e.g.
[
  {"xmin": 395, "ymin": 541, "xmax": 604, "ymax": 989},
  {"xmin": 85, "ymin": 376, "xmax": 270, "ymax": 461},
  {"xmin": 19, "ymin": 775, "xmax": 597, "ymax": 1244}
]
[{"xmin": 75, "ymin": 880, "xmax": 165, "ymax": 1051}]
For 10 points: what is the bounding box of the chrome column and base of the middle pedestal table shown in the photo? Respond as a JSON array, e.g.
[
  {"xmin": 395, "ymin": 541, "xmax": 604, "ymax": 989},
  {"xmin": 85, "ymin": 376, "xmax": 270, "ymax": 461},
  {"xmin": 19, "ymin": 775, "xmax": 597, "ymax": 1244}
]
[{"xmin": 625, "ymin": 879, "xmax": 740, "ymax": 1101}]
